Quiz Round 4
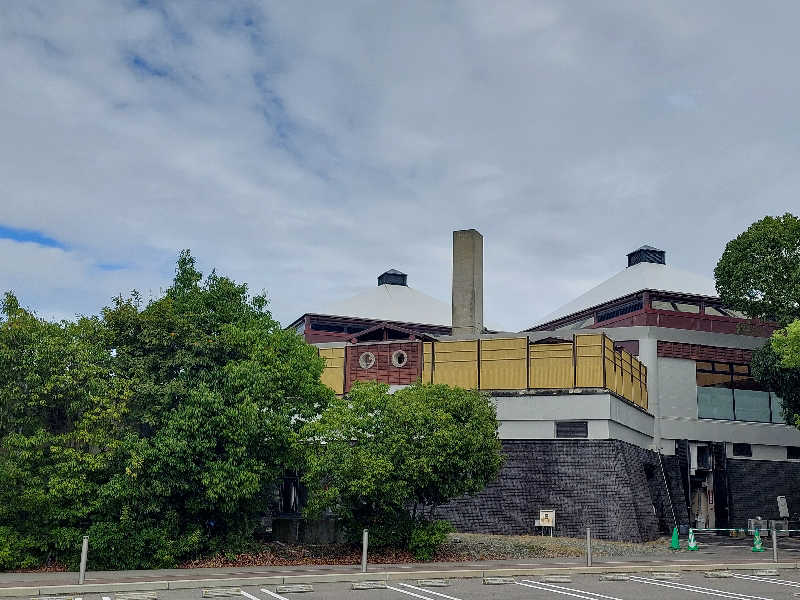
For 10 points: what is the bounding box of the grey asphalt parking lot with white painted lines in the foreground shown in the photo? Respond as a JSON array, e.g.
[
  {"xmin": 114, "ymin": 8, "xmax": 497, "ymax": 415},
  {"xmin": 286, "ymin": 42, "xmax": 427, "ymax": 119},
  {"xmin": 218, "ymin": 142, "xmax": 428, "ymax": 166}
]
[{"xmin": 45, "ymin": 570, "xmax": 800, "ymax": 600}]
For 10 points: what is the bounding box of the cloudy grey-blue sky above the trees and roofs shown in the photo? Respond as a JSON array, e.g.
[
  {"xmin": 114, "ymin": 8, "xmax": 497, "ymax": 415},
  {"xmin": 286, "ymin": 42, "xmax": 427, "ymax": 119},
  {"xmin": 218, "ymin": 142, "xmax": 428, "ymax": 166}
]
[{"xmin": 0, "ymin": 0, "xmax": 800, "ymax": 331}]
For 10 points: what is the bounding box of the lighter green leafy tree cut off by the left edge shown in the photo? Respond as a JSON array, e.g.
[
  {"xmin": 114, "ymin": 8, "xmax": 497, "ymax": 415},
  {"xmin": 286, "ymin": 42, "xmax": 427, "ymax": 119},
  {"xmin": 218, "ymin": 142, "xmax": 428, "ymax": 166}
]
[{"xmin": 0, "ymin": 293, "xmax": 131, "ymax": 568}]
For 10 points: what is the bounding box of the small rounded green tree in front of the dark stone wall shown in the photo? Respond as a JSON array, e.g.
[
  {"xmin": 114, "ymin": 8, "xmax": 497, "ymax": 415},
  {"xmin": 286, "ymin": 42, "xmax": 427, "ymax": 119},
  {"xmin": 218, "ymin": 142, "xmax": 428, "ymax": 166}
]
[{"xmin": 302, "ymin": 383, "xmax": 502, "ymax": 546}]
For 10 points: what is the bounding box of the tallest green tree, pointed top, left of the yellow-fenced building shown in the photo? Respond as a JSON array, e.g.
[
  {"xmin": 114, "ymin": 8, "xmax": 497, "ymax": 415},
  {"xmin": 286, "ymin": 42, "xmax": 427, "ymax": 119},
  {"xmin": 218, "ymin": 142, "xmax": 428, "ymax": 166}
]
[{"xmin": 93, "ymin": 251, "xmax": 333, "ymax": 565}]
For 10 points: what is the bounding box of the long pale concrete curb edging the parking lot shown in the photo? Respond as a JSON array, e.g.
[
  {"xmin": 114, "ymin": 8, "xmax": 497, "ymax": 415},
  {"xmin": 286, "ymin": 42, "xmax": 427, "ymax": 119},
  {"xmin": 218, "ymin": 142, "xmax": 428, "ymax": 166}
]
[{"xmin": 0, "ymin": 562, "xmax": 800, "ymax": 598}]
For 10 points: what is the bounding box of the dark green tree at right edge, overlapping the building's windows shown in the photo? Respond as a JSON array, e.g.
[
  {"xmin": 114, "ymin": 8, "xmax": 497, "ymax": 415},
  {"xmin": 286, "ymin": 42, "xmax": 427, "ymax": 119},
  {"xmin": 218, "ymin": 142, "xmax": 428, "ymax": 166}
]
[{"xmin": 714, "ymin": 213, "xmax": 800, "ymax": 427}]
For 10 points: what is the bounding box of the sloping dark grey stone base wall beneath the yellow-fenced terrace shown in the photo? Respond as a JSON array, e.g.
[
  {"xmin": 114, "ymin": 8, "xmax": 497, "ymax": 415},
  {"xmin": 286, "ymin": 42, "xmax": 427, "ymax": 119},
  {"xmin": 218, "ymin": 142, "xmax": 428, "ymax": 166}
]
[{"xmin": 436, "ymin": 440, "xmax": 688, "ymax": 541}]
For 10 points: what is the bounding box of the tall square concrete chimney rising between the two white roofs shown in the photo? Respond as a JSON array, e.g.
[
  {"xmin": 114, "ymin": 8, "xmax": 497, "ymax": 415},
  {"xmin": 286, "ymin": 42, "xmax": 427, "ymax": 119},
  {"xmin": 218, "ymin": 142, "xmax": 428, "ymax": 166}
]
[{"xmin": 452, "ymin": 229, "xmax": 483, "ymax": 337}]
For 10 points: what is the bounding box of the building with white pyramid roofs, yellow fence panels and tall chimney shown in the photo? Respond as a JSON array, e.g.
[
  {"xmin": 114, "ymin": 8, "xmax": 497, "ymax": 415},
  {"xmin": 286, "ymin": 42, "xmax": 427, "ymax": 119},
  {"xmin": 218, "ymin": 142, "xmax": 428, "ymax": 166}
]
[{"xmin": 292, "ymin": 230, "xmax": 800, "ymax": 539}]
